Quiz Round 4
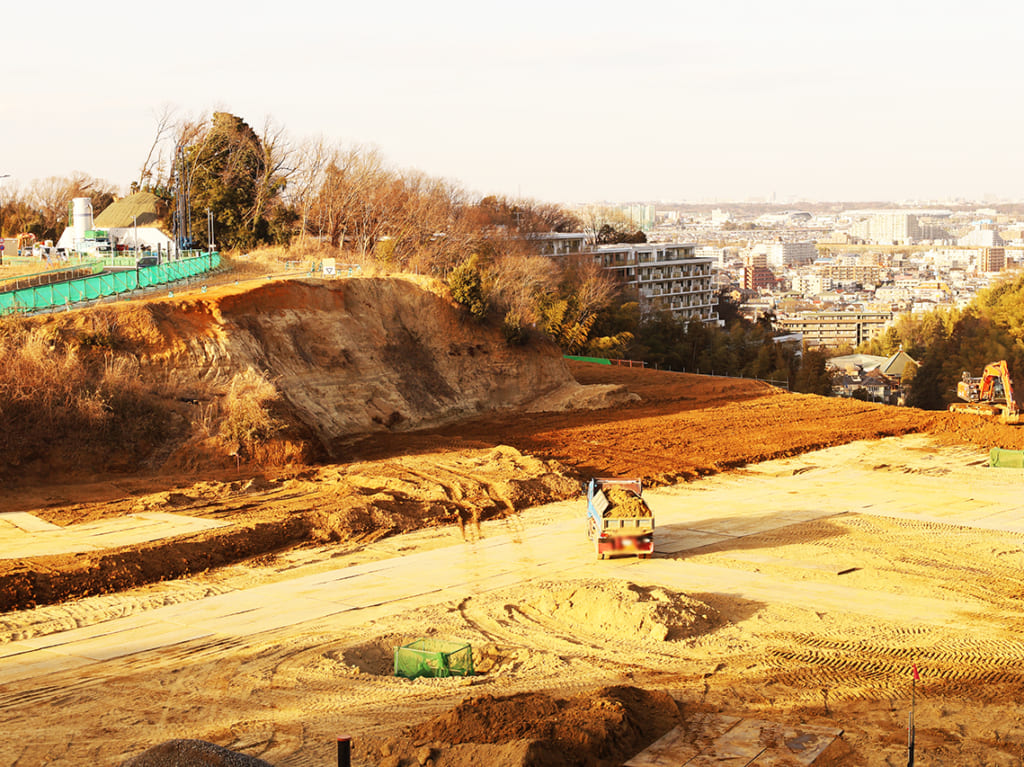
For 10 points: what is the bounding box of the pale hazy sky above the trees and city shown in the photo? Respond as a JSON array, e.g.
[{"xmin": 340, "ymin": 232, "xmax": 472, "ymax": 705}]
[{"xmin": 0, "ymin": 0, "xmax": 1024, "ymax": 203}]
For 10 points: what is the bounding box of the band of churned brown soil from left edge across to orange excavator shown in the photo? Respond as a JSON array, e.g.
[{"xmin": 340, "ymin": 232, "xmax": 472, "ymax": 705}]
[{"xmin": 0, "ymin": 363, "xmax": 1024, "ymax": 609}]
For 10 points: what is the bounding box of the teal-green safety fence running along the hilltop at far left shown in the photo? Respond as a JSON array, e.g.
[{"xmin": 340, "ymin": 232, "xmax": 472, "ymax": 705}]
[{"xmin": 0, "ymin": 253, "xmax": 220, "ymax": 314}]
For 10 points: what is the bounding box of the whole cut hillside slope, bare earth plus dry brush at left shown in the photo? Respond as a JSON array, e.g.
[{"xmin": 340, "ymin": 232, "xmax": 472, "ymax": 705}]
[{"xmin": 0, "ymin": 278, "xmax": 626, "ymax": 483}]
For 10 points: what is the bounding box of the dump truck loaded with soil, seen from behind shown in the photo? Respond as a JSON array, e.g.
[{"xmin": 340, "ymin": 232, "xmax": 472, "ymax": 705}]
[{"xmin": 587, "ymin": 477, "xmax": 654, "ymax": 559}]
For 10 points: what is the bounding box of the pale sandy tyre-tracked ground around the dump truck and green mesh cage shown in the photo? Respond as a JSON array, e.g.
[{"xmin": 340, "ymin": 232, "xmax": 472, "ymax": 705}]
[{"xmin": 6, "ymin": 436, "xmax": 1024, "ymax": 767}]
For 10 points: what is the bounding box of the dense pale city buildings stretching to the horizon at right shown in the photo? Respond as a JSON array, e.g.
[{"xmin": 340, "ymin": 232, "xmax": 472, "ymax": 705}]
[{"xmin": 589, "ymin": 200, "xmax": 1024, "ymax": 349}]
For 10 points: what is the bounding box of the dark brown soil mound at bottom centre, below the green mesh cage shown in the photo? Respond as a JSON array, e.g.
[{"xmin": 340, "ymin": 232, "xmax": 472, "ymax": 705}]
[{"xmin": 409, "ymin": 686, "xmax": 682, "ymax": 767}]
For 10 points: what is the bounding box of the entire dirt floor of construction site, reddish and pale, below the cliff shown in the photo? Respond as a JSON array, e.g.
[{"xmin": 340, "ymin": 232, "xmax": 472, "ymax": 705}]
[{"xmin": 0, "ymin": 365, "xmax": 1024, "ymax": 767}]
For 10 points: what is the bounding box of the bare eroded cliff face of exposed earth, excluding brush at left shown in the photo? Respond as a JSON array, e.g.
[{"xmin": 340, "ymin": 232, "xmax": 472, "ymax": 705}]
[{"xmin": 69, "ymin": 279, "xmax": 607, "ymax": 443}]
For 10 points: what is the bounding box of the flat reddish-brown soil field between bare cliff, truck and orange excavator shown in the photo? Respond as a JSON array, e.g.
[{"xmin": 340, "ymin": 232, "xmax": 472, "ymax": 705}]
[{"xmin": 342, "ymin": 363, "xmax": 1024, "ymax": 483}]
